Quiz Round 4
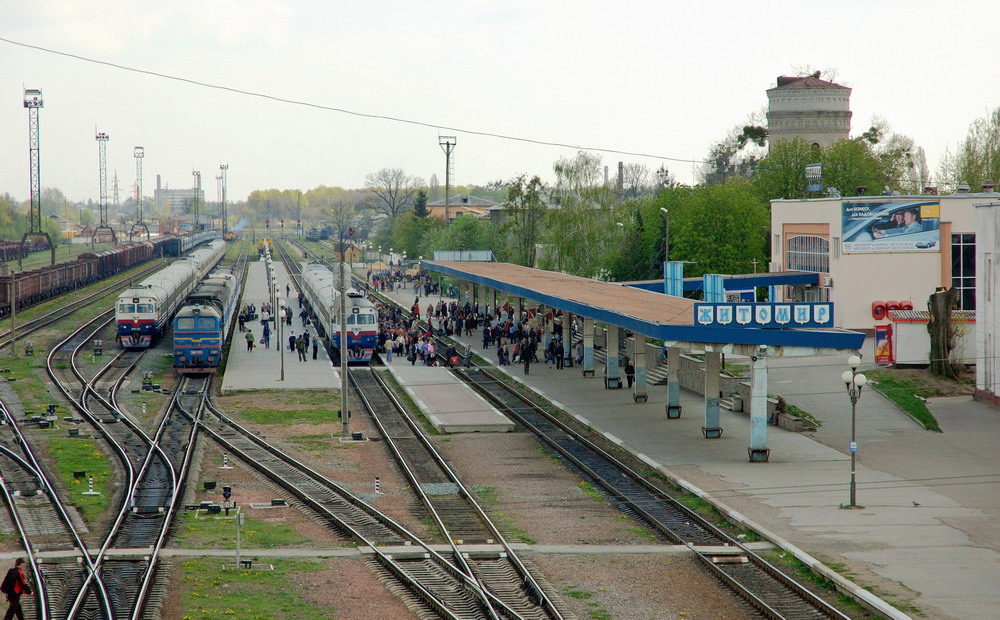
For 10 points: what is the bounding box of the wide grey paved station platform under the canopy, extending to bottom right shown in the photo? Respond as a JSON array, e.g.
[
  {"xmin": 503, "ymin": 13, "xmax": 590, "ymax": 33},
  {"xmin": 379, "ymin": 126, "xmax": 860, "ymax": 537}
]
[{"xmin": 376, "ymin": 290, "xmax": 1000, "ymax": 620}]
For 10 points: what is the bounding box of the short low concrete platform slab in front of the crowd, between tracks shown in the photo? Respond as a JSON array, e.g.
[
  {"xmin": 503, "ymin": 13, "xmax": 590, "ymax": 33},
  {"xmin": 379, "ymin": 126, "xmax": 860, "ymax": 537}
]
[{"xmin": 386, "ymin": 356, "xmax": 514, "ymax": 433}]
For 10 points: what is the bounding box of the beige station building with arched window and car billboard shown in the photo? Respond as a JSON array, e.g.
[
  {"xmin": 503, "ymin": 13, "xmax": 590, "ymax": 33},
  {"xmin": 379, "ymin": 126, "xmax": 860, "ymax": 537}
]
[{"xmin": 769, "ymin": 187, "xmax": 1000, "ymax": 331}]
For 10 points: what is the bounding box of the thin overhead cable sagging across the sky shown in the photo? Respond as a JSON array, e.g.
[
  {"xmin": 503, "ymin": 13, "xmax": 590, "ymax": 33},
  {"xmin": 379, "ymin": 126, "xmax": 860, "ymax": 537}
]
[{"xmin": 0, "ymin": 37, "xmax": 711, "ymax": 164}]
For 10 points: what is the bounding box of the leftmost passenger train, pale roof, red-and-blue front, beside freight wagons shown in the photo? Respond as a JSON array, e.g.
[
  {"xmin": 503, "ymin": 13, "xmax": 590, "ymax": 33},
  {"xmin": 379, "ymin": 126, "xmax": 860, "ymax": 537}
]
[{"xmin": 115, "ymin": 240, "xmax": 226, "ymax": 349}]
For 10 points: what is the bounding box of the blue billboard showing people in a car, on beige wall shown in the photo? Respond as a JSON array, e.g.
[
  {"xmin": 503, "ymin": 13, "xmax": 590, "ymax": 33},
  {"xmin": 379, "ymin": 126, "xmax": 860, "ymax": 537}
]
[{"xmin": 841, "ymin": 200, "xmax": 941, "ymax": 254}]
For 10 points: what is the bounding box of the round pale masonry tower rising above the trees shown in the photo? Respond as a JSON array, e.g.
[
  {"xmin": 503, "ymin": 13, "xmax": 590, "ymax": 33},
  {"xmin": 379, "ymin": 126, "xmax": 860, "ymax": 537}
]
[{"xmin": 767, "ymin": 71, "xmax": 852, "ymax": 148}]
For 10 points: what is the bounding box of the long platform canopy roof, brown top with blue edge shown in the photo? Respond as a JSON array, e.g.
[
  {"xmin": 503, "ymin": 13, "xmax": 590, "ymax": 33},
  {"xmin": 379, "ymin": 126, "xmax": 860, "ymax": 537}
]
[{"xmin": 422, "ymin": 261, "xmax": 864, "ymax": 354}]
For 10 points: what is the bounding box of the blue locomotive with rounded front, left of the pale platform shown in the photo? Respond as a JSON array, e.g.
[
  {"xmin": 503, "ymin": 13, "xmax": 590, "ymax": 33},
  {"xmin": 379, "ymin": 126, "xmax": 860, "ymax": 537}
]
[{"xmin": 173, "ymin": 267, "xmax": 240, "ymax": 374}]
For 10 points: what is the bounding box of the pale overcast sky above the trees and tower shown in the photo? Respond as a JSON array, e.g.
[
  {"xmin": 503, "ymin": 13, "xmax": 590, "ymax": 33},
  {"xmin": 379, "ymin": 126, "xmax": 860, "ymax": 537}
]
[{"xmin": 0, "ymin": 0, "xmax": 1000, "ymax": 201}]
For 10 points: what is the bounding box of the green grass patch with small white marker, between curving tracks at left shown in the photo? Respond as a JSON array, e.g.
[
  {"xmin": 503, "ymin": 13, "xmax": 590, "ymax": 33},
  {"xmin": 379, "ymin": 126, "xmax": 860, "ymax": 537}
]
[{"xmin": 48, "ymin": 437, "xmax": 111, "ymax": 522}]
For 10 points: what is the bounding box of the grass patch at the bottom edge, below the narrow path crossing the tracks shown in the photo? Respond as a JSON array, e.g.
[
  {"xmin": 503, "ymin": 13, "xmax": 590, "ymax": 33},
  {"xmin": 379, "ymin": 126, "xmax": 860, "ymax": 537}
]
[{"xmin": 179, "ymin": 558, "xmax": 326, "ymax": 620}]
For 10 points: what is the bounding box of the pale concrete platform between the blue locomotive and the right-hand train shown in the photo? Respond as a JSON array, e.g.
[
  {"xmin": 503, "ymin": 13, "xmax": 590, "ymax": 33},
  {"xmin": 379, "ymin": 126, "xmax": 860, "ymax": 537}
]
[{"xmin": 222, "ymin": 261, "xmax": 340, "ymax": 394}]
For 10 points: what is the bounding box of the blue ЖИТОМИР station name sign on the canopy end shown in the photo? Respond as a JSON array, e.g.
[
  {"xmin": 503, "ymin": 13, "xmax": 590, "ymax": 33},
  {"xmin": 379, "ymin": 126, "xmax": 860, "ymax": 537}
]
[{"xmin": 694, "ymin": 302, "xmax": 833, "ymax": 329}]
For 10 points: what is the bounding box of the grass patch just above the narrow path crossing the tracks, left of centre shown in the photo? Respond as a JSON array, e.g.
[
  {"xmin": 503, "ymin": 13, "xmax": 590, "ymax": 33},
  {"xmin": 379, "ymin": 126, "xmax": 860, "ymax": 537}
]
[{"xmin": 177, "ymin": 512, "xmax": 311, "ymax": 549}]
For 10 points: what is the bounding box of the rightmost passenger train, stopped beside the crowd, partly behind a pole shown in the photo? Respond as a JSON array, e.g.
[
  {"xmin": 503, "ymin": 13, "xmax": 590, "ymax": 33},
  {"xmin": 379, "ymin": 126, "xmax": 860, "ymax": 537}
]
[{"xmin": 302, "ymin": 262, "xmax": 378, "ymax": 363}]
